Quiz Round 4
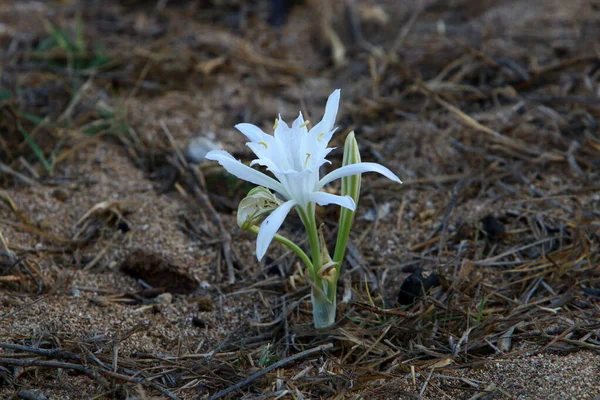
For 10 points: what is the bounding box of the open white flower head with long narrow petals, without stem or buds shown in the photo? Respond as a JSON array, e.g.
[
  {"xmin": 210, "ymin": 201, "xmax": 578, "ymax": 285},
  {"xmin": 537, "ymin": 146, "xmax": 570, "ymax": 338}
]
[{"xmin": 206, "ymin": 89, "xmax": 402, "ymax": 260}]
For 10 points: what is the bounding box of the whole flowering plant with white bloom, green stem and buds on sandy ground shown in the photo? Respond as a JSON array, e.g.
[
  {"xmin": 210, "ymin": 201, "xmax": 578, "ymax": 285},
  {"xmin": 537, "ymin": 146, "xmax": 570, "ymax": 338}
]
[{"xmin": 206, "ymin": 89, "xmax": 402, "ymax": 328}]
